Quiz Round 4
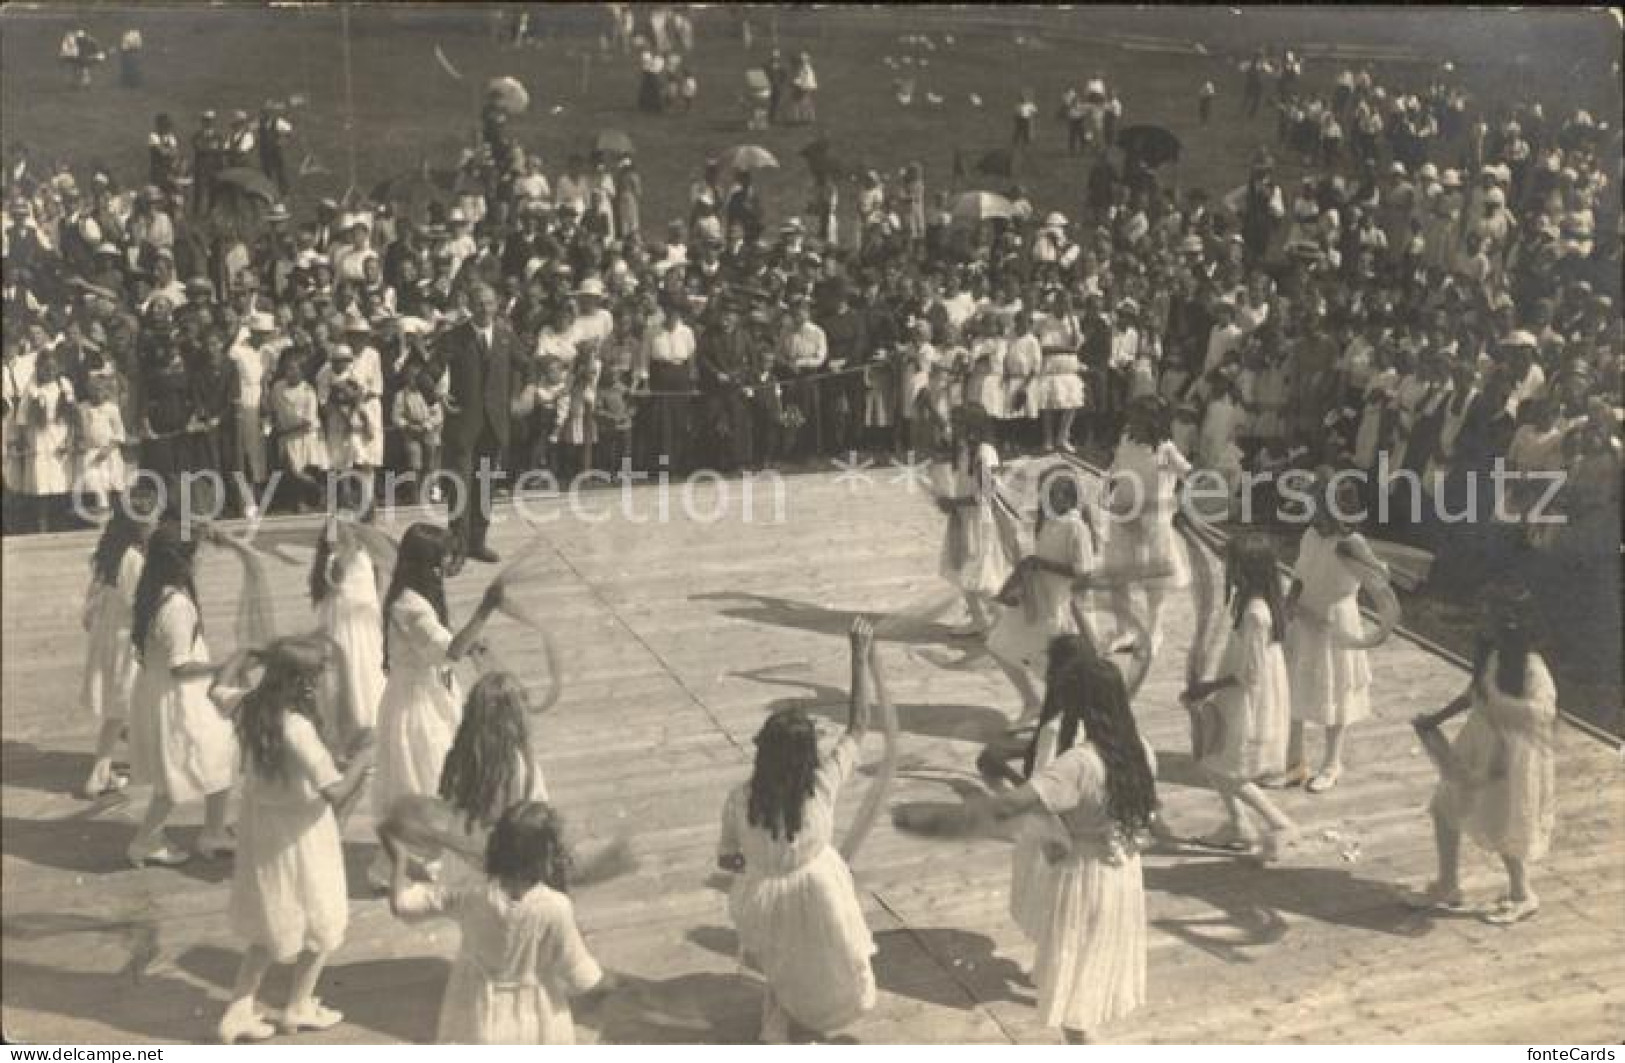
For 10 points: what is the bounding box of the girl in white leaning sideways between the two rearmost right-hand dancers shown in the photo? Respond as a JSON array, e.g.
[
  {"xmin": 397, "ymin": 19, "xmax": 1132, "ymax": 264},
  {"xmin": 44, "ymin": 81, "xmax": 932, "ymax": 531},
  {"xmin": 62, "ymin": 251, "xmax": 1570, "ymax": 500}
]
[{"xmin": 988, "ymin": 466, "xmax": 1095, "ymax": 723}]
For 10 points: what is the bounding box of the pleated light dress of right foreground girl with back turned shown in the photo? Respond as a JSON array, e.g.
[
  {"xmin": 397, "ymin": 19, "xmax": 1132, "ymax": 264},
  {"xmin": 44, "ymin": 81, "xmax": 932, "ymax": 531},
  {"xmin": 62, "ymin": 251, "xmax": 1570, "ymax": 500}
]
[{"xmin": 1029, "ymin": 741, "xmax": 1157, "ymax": 1030}]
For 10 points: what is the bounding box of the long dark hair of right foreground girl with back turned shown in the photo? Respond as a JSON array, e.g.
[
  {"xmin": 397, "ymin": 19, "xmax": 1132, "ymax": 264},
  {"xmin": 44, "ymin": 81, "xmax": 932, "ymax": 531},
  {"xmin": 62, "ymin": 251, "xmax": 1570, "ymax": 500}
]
[{"xmin": 1027, "ymin": 639, "xmax": 1157, "ymax": 835}]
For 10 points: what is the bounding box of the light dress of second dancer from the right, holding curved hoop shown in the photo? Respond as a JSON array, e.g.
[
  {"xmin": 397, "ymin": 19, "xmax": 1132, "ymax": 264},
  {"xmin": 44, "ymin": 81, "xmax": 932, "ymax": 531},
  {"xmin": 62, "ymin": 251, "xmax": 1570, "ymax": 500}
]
[{"xmin": 1287, "ymin": 528, "xmax": 1372, "ymax": 727}]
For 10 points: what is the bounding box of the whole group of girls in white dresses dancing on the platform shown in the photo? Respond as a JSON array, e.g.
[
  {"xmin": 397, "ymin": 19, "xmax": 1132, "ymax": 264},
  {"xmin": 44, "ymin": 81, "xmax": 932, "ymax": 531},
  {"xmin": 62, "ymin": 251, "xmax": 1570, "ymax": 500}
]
[{"xmin": 81, "ymin": 400, "xmax": 1557, "ymax": 1043}]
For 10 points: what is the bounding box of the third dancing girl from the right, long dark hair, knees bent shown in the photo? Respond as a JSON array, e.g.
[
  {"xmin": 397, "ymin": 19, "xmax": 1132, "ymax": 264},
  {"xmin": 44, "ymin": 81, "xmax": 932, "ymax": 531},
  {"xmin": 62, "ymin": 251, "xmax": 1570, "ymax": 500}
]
[{"xmin": 1183, "ymin": 535, "xmax": 1297, "ymax": 861}]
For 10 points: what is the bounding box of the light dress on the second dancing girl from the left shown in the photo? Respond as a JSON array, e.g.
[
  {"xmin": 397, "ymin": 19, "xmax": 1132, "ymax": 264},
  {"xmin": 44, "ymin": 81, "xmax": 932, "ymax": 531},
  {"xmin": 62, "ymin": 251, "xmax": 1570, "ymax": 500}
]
[{"xmin": 130, "ymin": 590, "xmax": 237, "ymax": 805}]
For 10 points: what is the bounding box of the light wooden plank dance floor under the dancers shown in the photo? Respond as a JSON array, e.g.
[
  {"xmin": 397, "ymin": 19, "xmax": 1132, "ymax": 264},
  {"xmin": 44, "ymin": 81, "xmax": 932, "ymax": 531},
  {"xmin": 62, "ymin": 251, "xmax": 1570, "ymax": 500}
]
[{"xmin": 0, "ymin": 476, "xmax": 1625, "ymax": 1043}]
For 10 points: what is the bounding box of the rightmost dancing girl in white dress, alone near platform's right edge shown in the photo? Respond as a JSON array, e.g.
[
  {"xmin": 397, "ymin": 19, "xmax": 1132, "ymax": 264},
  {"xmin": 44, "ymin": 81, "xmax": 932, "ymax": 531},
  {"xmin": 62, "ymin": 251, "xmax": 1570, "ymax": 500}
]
[{"xmin": 1414, "ymin": 600, "xmax": 1557, "ymax": 925}]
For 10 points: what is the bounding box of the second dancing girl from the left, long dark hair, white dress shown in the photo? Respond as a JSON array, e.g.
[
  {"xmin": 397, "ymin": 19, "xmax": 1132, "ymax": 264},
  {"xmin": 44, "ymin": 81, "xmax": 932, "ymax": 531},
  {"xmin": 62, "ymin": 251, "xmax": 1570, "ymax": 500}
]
[{"xmin": 127, "ymin": 522, "xmax": 237, "ymax": 868}]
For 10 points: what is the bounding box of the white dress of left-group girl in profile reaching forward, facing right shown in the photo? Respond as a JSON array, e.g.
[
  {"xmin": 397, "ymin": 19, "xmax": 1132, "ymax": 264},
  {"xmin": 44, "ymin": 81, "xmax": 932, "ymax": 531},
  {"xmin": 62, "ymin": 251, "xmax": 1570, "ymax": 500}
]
[{"xmin": 372, "ymin": 590, "xmax": 463, "ymax": 818}]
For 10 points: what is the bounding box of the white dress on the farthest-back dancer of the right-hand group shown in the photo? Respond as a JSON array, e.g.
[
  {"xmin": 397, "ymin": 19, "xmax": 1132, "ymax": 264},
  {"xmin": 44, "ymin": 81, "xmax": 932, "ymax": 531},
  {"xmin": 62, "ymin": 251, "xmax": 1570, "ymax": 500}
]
[{"xmin": 1105, "ymin": 439, "xmax": 1191, "ymax": 590}]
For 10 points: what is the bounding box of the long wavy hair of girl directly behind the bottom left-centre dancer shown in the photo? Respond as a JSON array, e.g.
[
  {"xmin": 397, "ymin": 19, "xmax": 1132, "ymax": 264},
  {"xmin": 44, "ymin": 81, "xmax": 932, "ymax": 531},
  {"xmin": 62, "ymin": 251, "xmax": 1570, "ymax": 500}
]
[{"xmin": 440, "ymin": 671, "xmax": 536, "ymax": 831}]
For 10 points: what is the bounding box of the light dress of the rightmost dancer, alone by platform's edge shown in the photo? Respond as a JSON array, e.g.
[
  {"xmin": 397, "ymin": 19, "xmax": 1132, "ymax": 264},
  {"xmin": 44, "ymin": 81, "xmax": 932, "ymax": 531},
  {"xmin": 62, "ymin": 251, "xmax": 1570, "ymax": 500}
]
[{"xmin": 1433, "ymin": 653, "xmax": 1557, "ymax": 860}]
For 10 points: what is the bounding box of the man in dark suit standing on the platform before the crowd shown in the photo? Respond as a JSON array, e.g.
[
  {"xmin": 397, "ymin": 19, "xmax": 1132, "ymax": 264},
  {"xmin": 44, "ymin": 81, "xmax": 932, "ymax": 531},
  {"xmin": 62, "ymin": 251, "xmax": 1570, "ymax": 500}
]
[{"xmin": 439, "ymin": 284, "xmax": 520, "ymax": 562}]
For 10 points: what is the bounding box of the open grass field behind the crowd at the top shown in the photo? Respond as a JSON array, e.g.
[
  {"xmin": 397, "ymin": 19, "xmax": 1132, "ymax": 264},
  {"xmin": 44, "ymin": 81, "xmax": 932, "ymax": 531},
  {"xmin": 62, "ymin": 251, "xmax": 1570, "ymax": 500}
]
[{"xmin": 0, "ymin": 5, "xmax": 1620, "ymax": 229}]
